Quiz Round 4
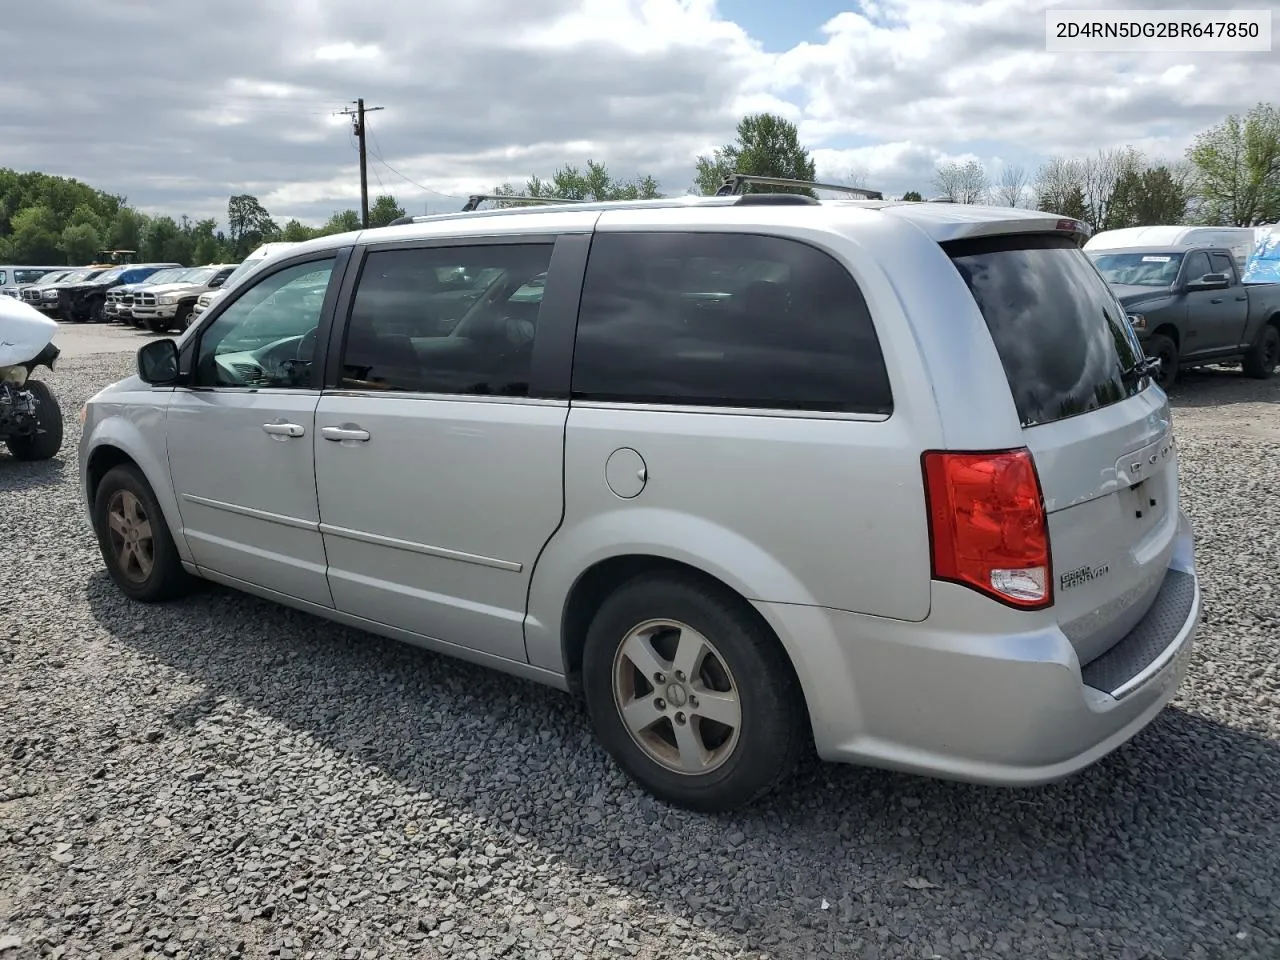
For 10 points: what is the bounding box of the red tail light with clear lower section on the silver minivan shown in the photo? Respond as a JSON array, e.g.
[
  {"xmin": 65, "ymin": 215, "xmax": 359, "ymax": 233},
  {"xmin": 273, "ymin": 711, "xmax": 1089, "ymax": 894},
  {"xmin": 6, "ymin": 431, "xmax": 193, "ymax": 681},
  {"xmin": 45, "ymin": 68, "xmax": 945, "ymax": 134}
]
[{"xmin": 922, "ymin": 448, "xmax": 1053, "ymax": 609}]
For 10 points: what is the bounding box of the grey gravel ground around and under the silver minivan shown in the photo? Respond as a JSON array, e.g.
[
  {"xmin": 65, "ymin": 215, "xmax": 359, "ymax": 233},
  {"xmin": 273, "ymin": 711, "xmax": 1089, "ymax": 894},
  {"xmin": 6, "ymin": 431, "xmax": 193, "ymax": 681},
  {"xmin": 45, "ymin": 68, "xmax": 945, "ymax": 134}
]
[{"xmin": 0, "ymin": 345, "xmax": 1280, "ymax": 960}]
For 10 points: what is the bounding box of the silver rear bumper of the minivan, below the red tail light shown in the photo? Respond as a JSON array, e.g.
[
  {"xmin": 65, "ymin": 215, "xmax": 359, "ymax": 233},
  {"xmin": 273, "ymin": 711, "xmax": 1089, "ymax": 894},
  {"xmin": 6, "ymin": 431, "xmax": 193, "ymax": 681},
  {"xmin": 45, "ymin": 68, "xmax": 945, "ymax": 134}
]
[{"xmin": 758, "ymin": 516, "xmax": 1202, "ymax": 786}]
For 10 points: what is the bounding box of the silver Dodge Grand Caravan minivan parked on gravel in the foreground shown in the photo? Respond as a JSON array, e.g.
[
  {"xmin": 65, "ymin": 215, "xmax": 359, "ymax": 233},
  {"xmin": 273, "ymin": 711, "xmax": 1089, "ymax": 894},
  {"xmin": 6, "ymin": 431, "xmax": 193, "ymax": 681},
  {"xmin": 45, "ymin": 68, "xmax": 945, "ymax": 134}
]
[{"xmin": 79, "ymin": 195, "xmax": 1201, "ymax": 810}]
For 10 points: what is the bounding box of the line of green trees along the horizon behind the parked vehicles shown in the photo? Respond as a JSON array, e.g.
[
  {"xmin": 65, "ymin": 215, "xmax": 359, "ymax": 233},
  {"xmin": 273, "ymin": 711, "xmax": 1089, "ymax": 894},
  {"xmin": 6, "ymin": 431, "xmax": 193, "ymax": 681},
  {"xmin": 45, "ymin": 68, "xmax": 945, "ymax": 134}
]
[{"xmin": 0, "ymin": 102, "xmax": 1280, "ymax": 265}]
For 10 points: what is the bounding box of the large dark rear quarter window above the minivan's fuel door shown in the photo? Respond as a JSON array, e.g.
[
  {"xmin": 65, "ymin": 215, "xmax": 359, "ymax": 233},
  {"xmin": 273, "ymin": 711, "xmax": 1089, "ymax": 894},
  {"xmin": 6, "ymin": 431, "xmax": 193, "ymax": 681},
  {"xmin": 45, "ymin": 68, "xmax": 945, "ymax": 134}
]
[{"xmin": 572, "ymin": 232, "xmax": 892, "ymax": 415}]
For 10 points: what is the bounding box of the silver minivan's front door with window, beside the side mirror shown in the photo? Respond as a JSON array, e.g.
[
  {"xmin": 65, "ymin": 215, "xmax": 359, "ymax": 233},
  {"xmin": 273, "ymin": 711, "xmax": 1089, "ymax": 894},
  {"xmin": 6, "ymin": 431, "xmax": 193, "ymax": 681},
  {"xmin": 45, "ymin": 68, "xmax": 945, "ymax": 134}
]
[{"xmin": 168, "ymin": 256, "xmax": 335, "ymax": 607}]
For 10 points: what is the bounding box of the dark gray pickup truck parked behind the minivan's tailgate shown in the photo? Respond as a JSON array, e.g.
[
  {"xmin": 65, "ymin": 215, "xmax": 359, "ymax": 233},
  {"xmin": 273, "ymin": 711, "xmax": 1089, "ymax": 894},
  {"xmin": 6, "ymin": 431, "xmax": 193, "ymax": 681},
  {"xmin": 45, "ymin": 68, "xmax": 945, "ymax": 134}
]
[{"xmin": 1088, "ymin": 247, "xmax": 1280, "ymax": 388}]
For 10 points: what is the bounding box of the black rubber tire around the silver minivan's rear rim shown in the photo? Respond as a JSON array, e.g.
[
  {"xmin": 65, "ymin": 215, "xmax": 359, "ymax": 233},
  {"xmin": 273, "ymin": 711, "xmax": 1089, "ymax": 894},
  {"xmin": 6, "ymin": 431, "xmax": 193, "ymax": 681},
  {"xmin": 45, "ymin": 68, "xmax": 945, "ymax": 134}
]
[{"xmin": 582, "ymin": 575, "xmax": 809, "ymax": 813}]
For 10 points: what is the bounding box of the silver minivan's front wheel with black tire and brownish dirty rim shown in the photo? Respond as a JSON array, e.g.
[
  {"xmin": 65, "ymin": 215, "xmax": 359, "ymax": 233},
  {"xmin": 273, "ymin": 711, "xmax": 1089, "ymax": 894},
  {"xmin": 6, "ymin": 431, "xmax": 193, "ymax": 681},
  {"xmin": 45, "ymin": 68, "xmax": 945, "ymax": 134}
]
[{"xmin": 93, "ymin": 463, "xmax": 192, "ymax": 603}]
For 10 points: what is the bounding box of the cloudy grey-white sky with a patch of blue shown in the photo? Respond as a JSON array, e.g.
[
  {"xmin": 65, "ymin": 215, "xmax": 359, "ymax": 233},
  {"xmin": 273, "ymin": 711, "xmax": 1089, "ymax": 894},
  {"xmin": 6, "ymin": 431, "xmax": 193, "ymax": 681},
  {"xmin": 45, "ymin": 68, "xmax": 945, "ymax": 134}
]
[{"xmin": 0, "ymin": 0, "xmax": 1280, "ymax": 223}]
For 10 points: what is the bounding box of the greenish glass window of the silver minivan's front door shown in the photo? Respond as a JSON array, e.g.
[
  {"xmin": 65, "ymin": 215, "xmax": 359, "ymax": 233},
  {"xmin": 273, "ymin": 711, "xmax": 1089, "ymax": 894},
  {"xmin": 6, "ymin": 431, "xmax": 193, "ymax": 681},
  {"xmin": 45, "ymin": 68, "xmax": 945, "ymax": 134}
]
[{"xmin": 195, "ymin": 257, "xmax": 334, "ymax": 389}]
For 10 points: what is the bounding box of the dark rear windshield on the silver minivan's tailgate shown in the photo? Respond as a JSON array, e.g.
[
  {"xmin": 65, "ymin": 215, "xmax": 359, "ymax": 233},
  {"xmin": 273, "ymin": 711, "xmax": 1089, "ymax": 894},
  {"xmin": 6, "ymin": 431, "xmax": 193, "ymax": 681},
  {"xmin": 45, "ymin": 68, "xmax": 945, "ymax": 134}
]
[{"xmin": 945, "ymin": 236, "xmax": 1147, "ymax": 426}]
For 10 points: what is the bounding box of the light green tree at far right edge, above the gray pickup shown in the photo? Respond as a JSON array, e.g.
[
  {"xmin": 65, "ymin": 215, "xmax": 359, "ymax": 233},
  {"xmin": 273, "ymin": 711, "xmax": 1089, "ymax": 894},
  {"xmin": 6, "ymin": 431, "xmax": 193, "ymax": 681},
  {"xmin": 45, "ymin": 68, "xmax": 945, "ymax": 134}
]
[{"xmin": 1187, "ymin": 102, "xmax": 1280, "ymax": 227}]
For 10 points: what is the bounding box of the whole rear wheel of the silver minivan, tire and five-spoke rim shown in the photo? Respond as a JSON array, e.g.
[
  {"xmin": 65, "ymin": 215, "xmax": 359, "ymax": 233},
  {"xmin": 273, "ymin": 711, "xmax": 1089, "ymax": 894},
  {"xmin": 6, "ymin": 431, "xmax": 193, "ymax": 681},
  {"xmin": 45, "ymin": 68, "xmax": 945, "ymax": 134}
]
[{"xmin": 582, "ymin": 575, "xmax": 808, "ymax": 813}]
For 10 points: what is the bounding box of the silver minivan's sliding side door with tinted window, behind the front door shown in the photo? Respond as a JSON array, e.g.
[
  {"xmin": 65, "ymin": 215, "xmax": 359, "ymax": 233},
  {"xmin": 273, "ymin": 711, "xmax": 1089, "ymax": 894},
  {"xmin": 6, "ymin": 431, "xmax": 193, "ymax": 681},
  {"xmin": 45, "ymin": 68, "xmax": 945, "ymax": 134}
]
[{"xmin": 314, "ymin": 239, "xmax": 568, "ymax": 662}]
